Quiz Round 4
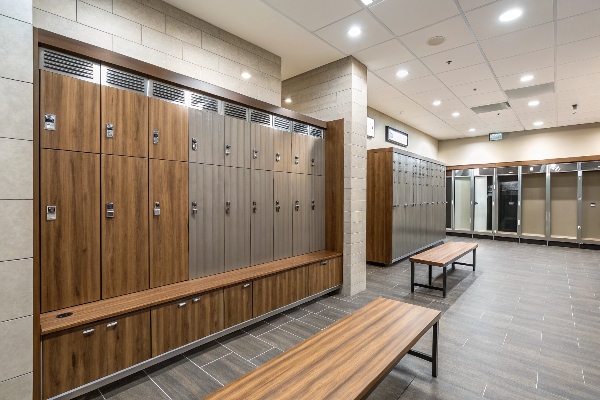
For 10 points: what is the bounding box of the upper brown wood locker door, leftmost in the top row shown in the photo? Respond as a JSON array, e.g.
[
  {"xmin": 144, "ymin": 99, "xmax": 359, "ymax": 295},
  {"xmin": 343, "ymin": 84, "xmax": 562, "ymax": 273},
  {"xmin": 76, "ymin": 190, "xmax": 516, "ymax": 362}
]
[{"xmin": 40, "ymin": 71, "xmax": 100, "ymax": 153}]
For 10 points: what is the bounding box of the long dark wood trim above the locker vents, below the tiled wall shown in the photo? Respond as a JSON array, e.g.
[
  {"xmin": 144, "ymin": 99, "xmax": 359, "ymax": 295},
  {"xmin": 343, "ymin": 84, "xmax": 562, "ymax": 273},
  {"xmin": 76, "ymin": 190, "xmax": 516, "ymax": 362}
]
[{"xmin": 35, "ymin": 29, "xmax": 327, "ymax": 128}]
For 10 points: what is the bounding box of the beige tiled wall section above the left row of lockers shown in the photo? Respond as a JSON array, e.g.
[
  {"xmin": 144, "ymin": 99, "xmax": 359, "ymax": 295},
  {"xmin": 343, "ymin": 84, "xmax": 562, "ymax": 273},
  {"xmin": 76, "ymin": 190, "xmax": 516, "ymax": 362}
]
[{"xmin": 32, "ymin": 0, "xmax": 281, "ymax": 105}]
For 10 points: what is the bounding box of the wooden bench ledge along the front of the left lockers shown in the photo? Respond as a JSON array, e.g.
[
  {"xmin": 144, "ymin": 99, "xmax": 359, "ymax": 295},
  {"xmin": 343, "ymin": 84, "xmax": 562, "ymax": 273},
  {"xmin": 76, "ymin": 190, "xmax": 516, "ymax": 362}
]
[{"xmin": 40, "ymin": 250, "xmax": 341, "ymax": 335}]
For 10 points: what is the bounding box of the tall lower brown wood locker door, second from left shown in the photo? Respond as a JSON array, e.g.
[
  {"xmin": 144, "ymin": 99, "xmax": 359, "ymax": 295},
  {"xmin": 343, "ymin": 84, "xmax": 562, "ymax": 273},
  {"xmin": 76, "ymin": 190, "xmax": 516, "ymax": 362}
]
[{"xmin": 101, "ymin": 154, "xmax": 150, "ymax": 299}]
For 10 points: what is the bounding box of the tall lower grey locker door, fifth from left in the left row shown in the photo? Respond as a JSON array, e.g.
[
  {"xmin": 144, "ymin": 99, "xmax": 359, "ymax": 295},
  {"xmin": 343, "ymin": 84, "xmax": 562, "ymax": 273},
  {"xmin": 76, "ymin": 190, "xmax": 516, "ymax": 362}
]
[{"xmin": 225, "ymin": 167, "xmax": 252, "ymax": 271}]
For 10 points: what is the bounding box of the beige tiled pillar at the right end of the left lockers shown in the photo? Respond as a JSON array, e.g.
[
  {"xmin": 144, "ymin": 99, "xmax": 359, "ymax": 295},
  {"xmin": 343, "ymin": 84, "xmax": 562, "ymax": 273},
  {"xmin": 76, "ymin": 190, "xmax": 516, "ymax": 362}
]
[{"xmin": 282, "ymin": 57, "xmax": 367, "ymax": 294}]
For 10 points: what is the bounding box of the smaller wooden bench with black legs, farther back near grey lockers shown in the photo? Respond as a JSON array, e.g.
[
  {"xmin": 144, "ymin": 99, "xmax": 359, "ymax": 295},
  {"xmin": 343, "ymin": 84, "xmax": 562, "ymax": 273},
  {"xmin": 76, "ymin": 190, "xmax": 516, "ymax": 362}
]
[{"xmin": 410, "ymin": 242, "xmax": 478, "ymax": 297}]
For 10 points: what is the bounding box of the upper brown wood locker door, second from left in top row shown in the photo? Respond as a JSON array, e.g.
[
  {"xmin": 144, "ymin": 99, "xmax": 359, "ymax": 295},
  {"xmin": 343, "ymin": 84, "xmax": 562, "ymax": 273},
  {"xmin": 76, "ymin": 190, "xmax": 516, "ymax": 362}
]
[{"xmin": 100, "ymin": 86, "xmax": 148, "ymax": 157}]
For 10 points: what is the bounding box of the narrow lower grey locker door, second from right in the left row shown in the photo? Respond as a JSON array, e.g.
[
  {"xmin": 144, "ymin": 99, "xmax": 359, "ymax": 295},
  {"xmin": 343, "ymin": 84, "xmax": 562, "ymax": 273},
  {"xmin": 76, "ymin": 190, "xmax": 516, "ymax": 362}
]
[{"xmin": 292, "ymin": 174, "xmax": 312, "ymax": 256}]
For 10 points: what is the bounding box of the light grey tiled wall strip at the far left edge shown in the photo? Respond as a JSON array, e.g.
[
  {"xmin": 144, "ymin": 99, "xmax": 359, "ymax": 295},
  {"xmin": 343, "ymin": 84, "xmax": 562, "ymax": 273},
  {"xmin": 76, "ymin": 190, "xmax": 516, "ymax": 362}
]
[{"xmin": 0, "ymin": 0, "xmax": 33, "ymax": 400}]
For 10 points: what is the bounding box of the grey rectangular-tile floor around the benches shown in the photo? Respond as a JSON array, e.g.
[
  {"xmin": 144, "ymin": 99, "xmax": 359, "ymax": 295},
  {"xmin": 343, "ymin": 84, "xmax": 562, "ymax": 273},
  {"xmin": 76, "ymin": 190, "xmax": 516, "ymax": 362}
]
[{"xmin": 77, "ymin": 238, "xmax": 600, "ymax": 400}]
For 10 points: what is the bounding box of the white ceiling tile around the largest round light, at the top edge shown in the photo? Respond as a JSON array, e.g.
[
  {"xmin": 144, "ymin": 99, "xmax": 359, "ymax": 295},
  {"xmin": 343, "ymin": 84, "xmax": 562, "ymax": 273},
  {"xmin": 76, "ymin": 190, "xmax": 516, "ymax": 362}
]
[{"xmin": 465, "ymin": 0, "xmax": 554, "ymax": 40}]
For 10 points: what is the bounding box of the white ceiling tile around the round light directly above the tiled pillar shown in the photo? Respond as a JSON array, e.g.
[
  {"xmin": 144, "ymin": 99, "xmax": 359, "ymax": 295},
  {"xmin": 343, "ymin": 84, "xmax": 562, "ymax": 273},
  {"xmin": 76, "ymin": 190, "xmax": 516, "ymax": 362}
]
[{"xmin": 315, "ymin": 10, "xmax": 392, "ymax": 54}]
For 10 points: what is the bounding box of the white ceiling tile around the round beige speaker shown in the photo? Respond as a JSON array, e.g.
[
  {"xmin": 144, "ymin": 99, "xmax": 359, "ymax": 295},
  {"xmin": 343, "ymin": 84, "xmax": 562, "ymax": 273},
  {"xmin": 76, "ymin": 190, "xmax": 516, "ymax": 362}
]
[{"xmin": 400, "ymin": 15, "xmax": 474, "ymax": 57}]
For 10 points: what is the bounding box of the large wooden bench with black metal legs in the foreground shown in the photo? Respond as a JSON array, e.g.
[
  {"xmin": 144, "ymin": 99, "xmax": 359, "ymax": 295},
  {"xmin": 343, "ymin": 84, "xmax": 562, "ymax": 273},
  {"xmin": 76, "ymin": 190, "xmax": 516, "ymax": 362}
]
[{"xmin": 207, "ymin": 298, "xmax": 441, "ymax": 400}]
